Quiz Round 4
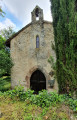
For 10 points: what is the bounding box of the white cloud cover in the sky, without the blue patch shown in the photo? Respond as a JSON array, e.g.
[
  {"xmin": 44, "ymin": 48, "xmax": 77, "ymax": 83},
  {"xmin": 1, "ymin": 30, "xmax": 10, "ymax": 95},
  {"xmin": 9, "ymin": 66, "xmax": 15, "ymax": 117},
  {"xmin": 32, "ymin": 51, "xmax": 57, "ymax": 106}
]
[{"xmin": 0, "ymin": 0, "xmax": 52, "ymax": 31}]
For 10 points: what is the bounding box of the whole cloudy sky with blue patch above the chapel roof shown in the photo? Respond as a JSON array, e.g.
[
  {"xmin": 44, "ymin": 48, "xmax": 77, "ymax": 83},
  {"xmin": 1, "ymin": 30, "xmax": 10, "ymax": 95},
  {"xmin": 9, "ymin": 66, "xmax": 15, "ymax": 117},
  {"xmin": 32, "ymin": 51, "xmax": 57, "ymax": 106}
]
[{"xmin": 0, "ymin": 0, "xmax": 52, "ymax": 31}]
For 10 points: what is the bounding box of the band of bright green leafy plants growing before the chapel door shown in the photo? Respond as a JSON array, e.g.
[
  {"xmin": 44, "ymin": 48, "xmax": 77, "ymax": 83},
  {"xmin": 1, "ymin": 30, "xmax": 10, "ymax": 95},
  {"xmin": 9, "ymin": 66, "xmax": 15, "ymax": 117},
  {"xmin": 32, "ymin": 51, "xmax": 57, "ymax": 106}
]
[{"xmin": 0, "ymin": 86, "xmax": 77, "ymax": 112}]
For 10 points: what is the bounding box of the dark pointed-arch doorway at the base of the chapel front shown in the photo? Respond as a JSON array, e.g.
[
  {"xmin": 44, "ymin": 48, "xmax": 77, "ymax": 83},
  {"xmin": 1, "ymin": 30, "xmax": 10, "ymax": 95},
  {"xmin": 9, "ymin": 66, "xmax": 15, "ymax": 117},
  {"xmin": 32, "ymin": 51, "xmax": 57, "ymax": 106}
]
[{"xmin": 30, "ymin": 70, "xmax": 46, "ymax": 93}]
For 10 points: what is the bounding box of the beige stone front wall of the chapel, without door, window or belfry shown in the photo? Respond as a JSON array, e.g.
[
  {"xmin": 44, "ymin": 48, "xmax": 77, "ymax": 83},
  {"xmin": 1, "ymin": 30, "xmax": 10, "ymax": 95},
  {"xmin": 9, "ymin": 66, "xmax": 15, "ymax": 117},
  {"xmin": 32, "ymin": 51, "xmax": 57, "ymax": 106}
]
[{"xmin": 11, "ymin": 21, "xmax": 58, "ymax": 91}]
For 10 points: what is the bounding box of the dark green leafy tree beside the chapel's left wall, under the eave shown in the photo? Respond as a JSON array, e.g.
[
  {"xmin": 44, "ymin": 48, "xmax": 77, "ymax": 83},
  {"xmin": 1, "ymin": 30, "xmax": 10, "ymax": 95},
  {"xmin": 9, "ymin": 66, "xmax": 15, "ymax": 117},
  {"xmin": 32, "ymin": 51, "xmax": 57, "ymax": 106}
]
[{"xmin": 0, "ymin": 35, "xmax": 13, "ymax": 77}]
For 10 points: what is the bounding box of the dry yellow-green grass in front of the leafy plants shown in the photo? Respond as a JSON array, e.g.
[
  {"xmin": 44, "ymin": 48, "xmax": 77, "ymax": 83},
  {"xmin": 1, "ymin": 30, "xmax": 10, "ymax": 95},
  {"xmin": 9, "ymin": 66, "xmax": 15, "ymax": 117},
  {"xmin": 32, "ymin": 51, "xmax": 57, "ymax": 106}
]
[{"xmin": 0, "ymin": 97, "xmax": 74, "ymax": 120}]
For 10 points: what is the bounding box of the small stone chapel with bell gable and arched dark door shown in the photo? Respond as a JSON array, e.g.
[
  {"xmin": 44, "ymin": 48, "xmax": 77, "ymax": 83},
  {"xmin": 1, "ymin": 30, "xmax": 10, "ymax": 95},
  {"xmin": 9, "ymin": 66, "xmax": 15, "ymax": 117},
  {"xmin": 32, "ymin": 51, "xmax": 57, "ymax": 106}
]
[{"xmin": 6, "ymin": 6, "xmax": 58, "ymax": 93}]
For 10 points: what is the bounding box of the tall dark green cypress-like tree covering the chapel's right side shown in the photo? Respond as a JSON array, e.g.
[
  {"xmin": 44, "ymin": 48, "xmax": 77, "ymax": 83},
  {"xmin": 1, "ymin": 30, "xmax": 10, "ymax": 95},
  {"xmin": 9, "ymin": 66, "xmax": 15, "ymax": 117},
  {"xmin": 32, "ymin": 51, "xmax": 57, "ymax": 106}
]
[{"xmin": 50, "ymin": 0, "xmax": 77, "ymax": 94}]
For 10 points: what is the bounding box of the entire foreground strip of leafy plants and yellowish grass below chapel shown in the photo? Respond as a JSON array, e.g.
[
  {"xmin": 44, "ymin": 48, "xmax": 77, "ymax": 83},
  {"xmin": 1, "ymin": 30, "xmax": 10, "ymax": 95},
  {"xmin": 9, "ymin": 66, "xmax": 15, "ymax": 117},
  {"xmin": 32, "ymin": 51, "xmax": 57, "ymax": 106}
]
[{"xmin": 0, "ymin": 87, "xmax": 77, "ymax": 120}]
